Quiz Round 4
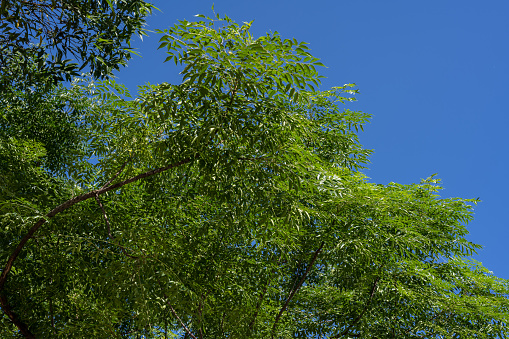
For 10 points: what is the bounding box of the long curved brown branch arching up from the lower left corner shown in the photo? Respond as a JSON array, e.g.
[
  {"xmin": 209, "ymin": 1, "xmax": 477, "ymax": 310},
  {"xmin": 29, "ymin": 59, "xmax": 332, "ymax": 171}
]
[{"xmin": 0, "ymin": 156, "xmax": 194, "ymax": 338}]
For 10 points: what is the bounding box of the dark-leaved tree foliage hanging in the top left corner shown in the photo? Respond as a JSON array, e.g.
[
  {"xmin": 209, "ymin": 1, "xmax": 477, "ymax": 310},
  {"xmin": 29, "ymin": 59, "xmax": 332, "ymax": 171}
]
[{"xmin": 0, "ymin": 0, "xmax": 154, "ymax": 89}]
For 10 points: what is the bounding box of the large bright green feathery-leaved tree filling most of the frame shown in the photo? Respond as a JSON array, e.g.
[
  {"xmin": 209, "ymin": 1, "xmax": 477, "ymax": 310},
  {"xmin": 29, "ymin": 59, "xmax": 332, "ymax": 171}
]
[{"xmin": 0, "ymin": 12, "xmax": 509, "ymax": 338}]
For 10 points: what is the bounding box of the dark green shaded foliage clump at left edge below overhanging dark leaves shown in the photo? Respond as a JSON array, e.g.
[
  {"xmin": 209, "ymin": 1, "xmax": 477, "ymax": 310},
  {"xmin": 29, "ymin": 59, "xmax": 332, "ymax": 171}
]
[{"xmin": 0, "ymin": 74, "xmax": 93, "ymax": 175}]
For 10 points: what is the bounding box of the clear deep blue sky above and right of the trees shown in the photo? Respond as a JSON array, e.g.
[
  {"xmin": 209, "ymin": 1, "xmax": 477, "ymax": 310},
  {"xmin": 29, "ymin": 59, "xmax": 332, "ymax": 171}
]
[{"xmin": 117, "ymin": 0, "xmax": 509, "ymax": 279}]
